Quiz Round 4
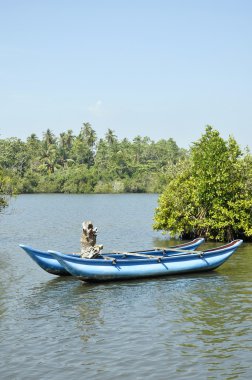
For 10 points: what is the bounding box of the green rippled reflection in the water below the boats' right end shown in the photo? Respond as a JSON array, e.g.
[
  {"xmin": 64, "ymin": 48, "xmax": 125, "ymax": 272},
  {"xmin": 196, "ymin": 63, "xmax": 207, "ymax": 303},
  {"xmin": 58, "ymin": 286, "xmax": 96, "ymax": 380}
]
[{"xmin": 157, "ymin": 272, "xmax": 251, "ymax": 378}]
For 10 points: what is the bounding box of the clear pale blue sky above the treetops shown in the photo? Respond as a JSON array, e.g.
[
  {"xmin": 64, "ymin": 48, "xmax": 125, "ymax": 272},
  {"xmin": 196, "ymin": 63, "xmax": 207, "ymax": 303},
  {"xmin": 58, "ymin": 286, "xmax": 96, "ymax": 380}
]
[{"xmin": 0, "ymin": 0, "xmax": 252, "ymax": 148}]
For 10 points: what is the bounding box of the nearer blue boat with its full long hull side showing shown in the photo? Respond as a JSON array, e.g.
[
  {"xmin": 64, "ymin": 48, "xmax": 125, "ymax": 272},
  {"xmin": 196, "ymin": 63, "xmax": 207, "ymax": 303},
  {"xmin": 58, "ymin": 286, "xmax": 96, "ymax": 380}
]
[{"xmin": 49, "ymin": 240, "xmax": 243, "ymax": 282}]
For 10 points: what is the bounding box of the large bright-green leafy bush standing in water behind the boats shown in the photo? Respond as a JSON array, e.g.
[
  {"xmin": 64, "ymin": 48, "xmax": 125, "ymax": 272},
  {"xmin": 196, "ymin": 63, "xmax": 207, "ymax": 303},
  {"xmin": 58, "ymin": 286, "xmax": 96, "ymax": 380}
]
[{"xmin": 154, "ymin": 126, "xmax": 252, "ymax": 240}]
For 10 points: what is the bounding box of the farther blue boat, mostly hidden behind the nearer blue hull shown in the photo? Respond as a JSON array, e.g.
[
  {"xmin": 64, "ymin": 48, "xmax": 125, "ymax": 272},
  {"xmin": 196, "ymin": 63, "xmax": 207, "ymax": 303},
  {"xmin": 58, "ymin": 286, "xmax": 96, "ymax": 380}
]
[{"xmin": 19, "ymin": 238, "xmax": 205, "ymax": 276}]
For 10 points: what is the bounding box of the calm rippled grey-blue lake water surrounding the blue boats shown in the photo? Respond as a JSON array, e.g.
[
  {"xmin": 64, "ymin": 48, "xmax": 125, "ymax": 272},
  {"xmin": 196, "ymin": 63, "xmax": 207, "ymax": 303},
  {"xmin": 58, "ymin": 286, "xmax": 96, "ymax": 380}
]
[{"xmin": 0, "ymin": 194, "xmax": 252, "ymax": 380}]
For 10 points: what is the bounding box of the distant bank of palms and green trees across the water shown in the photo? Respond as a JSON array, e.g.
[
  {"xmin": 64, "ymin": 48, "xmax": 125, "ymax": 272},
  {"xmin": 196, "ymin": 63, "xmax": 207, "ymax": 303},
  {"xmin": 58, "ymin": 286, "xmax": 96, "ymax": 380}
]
[{"xmin": 0, "ymin": 123, "xmax": 188, "ymax": 196}]
